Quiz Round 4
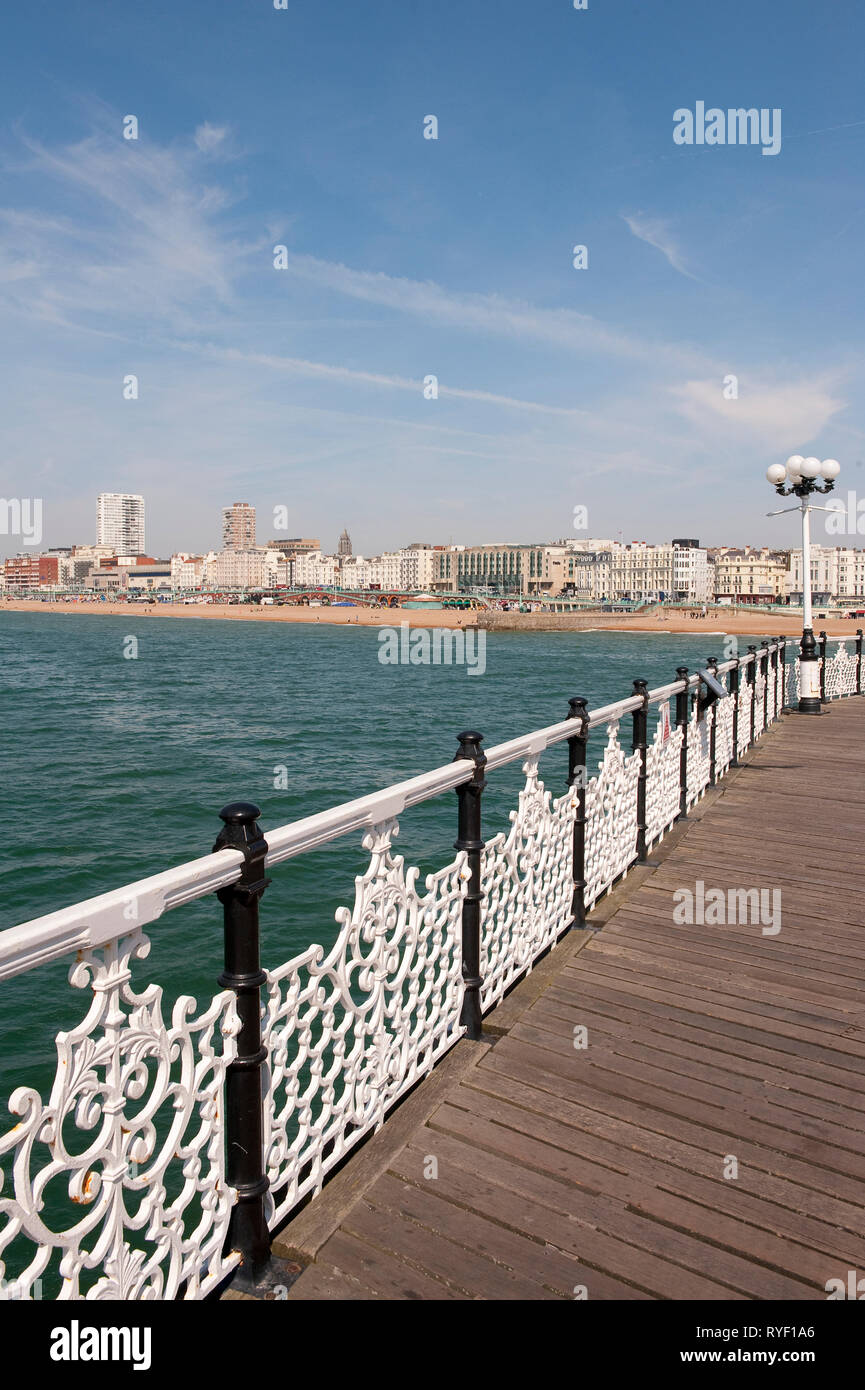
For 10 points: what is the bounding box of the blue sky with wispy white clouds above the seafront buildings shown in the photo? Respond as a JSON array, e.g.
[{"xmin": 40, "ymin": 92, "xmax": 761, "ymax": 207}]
[{"xmin": 0, "ymin": 0, "xmax": 865, "ymax": 555}]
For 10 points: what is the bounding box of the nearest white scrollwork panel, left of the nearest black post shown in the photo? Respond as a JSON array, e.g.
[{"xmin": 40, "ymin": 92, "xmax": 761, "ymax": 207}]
[{"xmin": 0, "ymin": 930, "xmax": 238, "ymax": 1300}]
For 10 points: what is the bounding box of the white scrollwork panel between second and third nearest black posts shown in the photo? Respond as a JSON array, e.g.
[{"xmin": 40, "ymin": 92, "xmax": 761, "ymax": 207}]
[{"xmin": 481, "ymin": 756, "xmax": 577, "ymax": 1009}]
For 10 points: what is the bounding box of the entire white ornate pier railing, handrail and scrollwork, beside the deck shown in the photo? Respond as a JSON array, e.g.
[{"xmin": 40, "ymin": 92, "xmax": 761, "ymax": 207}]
[{"xmin": 0, "ymin": 644, "xmax": 861, "ymax": 1300}]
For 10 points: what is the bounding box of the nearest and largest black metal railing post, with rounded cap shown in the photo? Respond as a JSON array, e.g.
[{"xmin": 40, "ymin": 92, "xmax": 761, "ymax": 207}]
[{"xmin": 213, "ymin": 801, "xmax": 270, "ymax": 1287}]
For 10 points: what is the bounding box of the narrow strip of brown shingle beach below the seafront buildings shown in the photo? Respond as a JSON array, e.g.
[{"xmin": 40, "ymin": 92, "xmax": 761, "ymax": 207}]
[{"xmin": 0, "ymin": 599, "xmax": 865, "ymax": 641}]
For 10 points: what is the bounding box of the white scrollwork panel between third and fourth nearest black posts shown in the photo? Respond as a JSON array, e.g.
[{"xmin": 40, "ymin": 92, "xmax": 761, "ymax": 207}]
[{"xmin": 585, "ymin": 719, "xmax": 640, "ymax": 909}]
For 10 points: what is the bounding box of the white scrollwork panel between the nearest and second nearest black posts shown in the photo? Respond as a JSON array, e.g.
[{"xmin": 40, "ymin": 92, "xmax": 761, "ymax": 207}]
[{"xmin": 264, "ymin": 819, "xmax": 469, "ymax": 1222}]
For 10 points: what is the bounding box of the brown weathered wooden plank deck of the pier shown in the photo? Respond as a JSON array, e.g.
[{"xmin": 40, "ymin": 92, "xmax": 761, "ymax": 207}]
[{"xmin": 264, "ymin": 699, "xmax": 865, "ymax": 1301}]
